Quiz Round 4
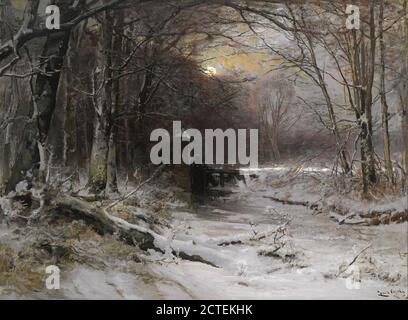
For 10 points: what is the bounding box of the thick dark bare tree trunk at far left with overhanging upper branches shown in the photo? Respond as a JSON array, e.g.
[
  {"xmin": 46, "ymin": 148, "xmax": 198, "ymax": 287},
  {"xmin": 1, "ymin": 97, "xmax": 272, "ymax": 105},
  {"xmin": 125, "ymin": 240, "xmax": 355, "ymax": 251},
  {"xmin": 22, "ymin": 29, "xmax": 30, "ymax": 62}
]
[{"xmin": 0, "ymin": 0, "xmax": 130, "ymax": 192}]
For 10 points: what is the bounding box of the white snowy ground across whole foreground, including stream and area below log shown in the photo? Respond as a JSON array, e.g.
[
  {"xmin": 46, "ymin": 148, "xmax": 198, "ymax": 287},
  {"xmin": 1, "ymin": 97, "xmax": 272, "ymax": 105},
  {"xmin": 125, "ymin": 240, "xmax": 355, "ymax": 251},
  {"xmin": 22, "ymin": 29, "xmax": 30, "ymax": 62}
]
[{"xmin": 0, "ymin": 170, "xmax": 408, "ymax": 299}]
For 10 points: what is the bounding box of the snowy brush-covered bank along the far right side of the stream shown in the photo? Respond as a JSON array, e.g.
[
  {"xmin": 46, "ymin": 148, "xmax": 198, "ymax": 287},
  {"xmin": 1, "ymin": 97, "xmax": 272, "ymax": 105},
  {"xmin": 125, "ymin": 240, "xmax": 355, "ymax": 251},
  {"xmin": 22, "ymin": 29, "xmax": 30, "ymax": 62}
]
[{"xmin": 249, "ymin": 166, "xmax": 408, "ymax": 225}]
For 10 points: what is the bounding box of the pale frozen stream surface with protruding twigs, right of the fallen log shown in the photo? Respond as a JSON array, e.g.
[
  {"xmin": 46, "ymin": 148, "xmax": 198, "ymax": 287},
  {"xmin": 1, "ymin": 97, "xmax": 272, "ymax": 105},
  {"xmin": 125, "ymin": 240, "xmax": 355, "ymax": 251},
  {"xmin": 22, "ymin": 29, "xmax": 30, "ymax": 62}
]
[{"xmin": 147, "ymin": 180, "xmax": 408, "ymax": 299}]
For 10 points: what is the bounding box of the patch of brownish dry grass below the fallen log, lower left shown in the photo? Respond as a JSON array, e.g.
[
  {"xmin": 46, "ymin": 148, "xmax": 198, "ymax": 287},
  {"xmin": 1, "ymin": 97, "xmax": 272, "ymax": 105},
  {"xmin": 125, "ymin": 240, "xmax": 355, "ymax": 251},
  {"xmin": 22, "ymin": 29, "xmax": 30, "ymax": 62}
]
[{"xmin": 0, "ymin": 221, "xmax": 147, "ymax": 296}]
